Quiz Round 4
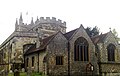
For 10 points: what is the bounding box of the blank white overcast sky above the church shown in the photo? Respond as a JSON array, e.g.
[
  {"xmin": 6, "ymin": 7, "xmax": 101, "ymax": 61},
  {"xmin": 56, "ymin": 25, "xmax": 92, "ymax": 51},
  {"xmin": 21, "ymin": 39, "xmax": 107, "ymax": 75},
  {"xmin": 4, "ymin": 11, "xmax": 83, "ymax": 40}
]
[{"xmin": 0, "ymin": 0, "xmax": 120, "ymax": 43}]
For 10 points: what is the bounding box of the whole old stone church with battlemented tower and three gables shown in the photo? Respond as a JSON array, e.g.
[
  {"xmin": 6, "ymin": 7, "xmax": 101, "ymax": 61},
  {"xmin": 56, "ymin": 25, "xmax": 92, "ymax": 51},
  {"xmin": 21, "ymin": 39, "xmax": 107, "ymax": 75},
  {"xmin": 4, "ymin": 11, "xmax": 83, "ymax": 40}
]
[{"xmin": 0, "ymin": 15, "xmax": 120, "ymax": 76}]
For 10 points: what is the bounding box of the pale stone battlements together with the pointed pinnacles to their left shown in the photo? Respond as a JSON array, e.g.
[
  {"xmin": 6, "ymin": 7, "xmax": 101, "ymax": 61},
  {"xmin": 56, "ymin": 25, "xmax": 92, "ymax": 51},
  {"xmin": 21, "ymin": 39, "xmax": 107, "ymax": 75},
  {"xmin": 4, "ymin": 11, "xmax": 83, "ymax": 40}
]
[{"xmin": 15, "ymin": 16, "xmax": 66, "ymax": 31}]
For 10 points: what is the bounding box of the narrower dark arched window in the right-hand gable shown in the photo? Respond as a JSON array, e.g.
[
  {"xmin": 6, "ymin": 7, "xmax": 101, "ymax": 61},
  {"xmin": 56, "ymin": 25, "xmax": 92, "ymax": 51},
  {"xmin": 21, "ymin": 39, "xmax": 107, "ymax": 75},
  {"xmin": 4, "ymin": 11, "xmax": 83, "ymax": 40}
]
[{"xmin": 107, "ymin": 44, "xmax": 115, "ymax": 61}]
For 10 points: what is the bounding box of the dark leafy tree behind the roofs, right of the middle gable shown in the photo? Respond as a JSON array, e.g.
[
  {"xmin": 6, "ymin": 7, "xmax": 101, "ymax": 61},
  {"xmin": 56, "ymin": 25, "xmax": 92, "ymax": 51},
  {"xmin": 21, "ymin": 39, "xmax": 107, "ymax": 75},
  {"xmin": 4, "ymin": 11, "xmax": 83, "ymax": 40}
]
[{"xmin": 85, "ymin": 26, "xmax": 100, "ymax": 37}]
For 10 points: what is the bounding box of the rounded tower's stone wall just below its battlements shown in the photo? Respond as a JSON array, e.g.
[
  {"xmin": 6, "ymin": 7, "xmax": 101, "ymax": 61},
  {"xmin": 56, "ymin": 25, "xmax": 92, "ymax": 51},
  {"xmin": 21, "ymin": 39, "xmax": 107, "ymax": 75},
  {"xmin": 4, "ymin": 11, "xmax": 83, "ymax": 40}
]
[{"xmin": 30, "ymin": 23, "xmax": 66, "ymax": 38}]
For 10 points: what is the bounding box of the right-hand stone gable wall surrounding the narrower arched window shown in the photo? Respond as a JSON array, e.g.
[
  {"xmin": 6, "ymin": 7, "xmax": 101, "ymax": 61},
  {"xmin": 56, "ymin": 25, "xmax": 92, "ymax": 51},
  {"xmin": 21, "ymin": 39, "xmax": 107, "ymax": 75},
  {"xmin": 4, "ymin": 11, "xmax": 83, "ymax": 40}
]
[{"xmin": 98, "ymin": 32, "xmax": 120, "ymax": 62}]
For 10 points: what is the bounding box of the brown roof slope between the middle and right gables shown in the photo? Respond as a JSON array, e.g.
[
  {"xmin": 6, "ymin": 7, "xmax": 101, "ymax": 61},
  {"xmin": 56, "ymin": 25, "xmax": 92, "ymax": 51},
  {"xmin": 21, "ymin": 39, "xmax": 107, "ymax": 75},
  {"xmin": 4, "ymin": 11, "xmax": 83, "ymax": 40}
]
[{"xmin": 91, "ymin": 33, "xmax": 108, "ymax": 44}]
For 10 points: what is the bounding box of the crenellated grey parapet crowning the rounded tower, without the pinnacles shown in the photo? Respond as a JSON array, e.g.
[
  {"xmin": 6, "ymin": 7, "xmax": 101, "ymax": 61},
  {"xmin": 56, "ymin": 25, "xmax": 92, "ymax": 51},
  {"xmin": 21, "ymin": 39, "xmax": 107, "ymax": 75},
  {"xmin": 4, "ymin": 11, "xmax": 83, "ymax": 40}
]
[{"xmin": 35, "ymin": 17, "xmax": 66, "ymax": 26}]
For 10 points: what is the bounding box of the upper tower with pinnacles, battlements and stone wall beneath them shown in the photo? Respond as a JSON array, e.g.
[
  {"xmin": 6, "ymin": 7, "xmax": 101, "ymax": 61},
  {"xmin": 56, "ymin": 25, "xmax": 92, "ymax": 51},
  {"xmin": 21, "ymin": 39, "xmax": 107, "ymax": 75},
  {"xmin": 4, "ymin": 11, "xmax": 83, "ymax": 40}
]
[{"xmin": 15, "ymin": 14, "xmax": 66, "ymax": 33}]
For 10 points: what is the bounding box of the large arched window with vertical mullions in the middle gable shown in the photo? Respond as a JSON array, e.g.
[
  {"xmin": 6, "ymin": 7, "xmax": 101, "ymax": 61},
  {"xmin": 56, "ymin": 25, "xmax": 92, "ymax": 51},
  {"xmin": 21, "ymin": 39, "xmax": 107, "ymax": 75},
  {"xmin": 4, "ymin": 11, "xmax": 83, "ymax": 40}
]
[{"xmin": 74, "ymin": 37, "xmax": 89, "ymax": 61}]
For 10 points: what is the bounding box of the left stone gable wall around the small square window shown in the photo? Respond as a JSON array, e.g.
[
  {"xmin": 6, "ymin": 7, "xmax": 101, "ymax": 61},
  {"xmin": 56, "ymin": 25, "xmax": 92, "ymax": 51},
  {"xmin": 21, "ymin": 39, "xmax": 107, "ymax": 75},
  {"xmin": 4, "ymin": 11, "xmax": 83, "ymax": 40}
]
[{"xmin": 47, "ymin": 32, "xmax": 68, "ymax": 76}]
